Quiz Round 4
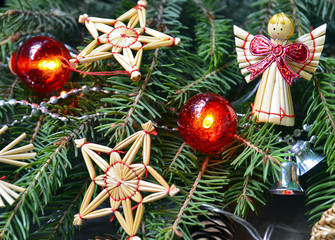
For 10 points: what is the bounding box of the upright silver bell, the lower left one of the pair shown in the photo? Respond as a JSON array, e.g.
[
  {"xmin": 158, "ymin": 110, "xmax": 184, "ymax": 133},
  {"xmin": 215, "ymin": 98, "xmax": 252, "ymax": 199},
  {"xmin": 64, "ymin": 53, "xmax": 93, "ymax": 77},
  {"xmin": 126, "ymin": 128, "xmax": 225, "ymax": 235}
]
[{"xmin": 269, "ymin": 156, "xmax": 304, "ymax": 195}]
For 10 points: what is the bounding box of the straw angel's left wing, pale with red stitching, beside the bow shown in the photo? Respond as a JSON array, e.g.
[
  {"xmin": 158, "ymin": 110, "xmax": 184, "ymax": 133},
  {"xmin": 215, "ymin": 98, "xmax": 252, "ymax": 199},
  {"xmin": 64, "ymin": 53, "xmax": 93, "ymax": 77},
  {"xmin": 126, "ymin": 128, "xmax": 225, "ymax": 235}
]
[{"xmin": 234, "ymin": 25, "xmax": 266, "ymax": 83}]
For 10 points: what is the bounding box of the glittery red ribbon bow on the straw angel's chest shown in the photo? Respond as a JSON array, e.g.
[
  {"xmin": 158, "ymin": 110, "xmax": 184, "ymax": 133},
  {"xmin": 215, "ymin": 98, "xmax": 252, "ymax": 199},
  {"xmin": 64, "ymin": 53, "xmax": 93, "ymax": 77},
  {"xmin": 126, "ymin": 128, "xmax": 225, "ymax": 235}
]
[{"xmin": 247, "ymin": 35, "xmax": 309, "ymax": 86}]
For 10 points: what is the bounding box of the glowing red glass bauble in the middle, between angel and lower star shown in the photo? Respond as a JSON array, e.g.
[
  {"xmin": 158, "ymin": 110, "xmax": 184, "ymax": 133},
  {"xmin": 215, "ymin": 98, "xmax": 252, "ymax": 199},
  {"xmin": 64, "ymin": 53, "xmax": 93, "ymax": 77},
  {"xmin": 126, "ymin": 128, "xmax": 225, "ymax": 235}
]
[{"xmin": 178, "ymin": 93, "xmax": 237, "ymax": 154}]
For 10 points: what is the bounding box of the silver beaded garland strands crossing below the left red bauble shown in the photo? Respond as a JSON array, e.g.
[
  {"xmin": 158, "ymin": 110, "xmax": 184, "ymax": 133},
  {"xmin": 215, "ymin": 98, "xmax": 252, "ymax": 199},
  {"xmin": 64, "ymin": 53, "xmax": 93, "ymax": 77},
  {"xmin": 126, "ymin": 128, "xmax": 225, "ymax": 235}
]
[{"xmin": 0, "ymin": 85, "xmax": 110, "ymax": 126}]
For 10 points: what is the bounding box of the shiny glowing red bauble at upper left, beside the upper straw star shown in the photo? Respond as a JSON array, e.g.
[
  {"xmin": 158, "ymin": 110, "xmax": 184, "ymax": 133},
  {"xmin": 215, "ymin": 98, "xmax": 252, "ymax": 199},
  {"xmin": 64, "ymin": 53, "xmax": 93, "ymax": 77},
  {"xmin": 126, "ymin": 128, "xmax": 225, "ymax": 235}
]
[{"xmin": 11, "ymin": 36, "xmax": 71, "ymax": 92}]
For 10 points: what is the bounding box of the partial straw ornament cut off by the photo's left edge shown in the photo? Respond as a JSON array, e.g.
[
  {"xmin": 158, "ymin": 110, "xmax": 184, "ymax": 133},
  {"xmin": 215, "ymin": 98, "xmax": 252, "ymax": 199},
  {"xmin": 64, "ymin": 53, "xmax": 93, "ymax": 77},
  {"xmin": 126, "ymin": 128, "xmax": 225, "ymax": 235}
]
[{"xmin": 0, "ymin": 126, "xmax": 36, "ymax": 207}]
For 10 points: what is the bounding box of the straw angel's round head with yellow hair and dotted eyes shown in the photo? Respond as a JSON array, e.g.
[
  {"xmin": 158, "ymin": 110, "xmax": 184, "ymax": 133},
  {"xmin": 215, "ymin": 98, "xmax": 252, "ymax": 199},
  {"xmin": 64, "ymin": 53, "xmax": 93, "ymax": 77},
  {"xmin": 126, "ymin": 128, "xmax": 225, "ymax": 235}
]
[{"xmin": 268, "ymin": 13, "xmax": 294, "ymax": 40}]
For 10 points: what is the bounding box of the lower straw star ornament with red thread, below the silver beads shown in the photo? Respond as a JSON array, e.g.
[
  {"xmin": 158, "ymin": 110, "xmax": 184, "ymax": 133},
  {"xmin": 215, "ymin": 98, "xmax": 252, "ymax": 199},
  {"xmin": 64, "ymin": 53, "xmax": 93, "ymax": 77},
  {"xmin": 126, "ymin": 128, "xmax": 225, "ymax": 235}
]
[{"xmin": 73, "ymin": 121, "xmax": 179, "ymax": 240}]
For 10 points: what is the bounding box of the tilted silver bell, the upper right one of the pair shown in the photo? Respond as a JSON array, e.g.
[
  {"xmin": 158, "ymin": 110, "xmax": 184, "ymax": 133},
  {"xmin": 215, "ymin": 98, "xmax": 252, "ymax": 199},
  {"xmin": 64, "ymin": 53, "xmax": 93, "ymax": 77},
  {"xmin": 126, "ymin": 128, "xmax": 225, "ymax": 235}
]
[{"xmin": 290, "ymin": 140, "xmax": 325, "ymax": 176}]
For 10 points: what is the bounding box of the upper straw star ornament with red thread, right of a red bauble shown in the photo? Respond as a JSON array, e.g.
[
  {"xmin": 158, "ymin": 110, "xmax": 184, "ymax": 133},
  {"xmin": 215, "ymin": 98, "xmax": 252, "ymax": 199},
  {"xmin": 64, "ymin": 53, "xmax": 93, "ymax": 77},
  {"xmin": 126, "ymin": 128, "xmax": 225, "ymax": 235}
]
[{"xmin": 70, "ymin": 0, "xmax": 181, "ymax": 81}]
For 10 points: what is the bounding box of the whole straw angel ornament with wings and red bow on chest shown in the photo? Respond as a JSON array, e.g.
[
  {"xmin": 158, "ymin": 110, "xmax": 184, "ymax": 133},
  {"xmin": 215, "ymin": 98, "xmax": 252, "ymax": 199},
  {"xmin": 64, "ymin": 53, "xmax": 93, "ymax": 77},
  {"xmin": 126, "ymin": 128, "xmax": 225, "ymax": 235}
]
[{"xmin": 234, "ymin": 13, "xmax": 326, "ymax": 126}]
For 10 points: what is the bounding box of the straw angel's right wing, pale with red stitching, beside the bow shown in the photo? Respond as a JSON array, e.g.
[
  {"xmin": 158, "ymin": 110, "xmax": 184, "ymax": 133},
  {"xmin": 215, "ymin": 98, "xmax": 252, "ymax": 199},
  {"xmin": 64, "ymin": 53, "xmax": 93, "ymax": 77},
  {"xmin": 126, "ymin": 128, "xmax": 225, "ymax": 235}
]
[{"xmin": 286, "ymin": 24, "xmax": 327, "ymax": 80}]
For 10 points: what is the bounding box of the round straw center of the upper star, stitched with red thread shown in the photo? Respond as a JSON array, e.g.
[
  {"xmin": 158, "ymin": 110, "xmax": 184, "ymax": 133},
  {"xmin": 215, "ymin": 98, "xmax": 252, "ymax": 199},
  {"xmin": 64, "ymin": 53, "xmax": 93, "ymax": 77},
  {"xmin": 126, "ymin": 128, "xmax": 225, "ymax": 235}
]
[{"xmin": 107, "ymin": 26, "xmax": 139, "ymax": 48}]
